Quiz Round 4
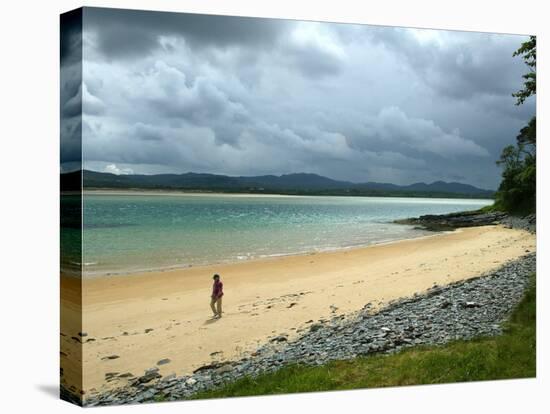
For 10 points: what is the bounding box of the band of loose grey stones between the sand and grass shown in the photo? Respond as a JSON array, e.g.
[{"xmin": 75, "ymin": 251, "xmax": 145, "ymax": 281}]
[{"xmin": 84, "ymin": 253, "xmax": 536, "ymax": 406}]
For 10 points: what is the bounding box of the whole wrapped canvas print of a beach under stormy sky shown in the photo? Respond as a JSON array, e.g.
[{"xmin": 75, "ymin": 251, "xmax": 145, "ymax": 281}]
[{"xmin": 60, "ymin": 7, "xmax": 536, "ymax": 406}]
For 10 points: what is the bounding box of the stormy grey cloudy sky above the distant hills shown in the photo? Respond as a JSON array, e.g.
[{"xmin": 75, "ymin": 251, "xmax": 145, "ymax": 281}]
[{"xmin": 61, "ymin": 8, "xmax": 535, "ymax": 189}]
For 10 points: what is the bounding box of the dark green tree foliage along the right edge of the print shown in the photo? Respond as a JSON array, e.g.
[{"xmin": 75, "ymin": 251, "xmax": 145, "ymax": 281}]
[{"xmin": 495, "ymin": 36, "xmax": 537, "ymax": 213}]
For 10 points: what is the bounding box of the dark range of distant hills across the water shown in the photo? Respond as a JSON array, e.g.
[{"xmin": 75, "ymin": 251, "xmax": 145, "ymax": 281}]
[{"xmin": 61, "ymin": 170, "xmax": 493, "ymax": 198}]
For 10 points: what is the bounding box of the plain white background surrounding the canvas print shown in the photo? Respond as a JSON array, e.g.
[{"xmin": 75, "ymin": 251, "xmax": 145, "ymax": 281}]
[{"xmin": 0, "ymin": 0, "xmax": 550, "ymax": 414}]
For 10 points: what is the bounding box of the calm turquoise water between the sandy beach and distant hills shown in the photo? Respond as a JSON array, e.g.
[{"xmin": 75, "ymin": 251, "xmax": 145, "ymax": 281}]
[{"xmin": 78, "ymin": 194, "xmax": 492, "ymax": 275}]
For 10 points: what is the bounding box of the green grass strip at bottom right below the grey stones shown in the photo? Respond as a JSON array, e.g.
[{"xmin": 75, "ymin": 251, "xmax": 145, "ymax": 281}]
[{"xmin": 193, "ymin": 275, "xmax": 536, "ymax": 399}]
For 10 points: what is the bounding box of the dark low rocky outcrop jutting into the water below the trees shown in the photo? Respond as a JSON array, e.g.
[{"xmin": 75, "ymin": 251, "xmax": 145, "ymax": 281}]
[{"xmin": 395, "ymin": 211, "xmax": 536, "ymax": 233}]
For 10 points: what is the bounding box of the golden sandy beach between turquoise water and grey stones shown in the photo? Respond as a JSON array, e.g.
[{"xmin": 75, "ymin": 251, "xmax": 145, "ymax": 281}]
[{"xmin": 61, "ymin": 226, "xmax": 536, "ymax": 393}]
